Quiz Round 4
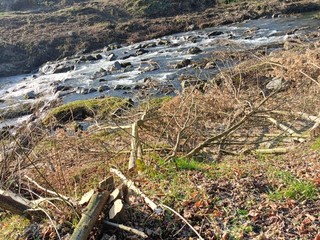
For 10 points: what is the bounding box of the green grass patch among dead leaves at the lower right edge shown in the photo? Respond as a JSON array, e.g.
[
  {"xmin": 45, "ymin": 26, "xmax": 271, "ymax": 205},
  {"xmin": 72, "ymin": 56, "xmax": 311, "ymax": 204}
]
[{"xmin": 269, "ymin": 171, "xmax": 318, "ymax": 200}]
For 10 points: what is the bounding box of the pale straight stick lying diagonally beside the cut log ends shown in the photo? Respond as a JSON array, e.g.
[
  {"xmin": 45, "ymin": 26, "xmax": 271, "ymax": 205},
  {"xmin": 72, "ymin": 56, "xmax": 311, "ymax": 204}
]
[{"xmin": 110, "ymin": 168, "xmax": 163, "ymax": 215}]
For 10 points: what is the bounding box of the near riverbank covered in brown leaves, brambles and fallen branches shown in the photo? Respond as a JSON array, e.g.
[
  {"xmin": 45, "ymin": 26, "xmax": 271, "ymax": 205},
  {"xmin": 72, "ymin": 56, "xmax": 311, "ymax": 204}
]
[{"xmin": 0, "ymin": 36, "xmax": 320, "ymax": 240}]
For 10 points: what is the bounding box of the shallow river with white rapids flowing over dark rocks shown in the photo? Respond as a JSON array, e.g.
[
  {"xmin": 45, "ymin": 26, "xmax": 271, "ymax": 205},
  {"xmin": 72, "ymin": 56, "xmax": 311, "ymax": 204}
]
[{"xmin": 0, "ymin": 14, "xmax": 320, "ymax": 128}]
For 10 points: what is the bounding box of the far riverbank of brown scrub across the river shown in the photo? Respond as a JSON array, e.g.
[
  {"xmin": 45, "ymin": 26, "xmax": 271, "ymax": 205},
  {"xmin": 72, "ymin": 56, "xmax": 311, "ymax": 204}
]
[{"xmin": 0, "ymin": 0, "xmax": 320, "ymax": 76}]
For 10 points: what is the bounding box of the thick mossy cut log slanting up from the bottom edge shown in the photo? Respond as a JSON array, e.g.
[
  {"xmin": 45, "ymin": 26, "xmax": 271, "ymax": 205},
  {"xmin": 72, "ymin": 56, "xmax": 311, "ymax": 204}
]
[{"xmin": 70, "ymin": 191, "xmax": 109, "ymax": 240}]
